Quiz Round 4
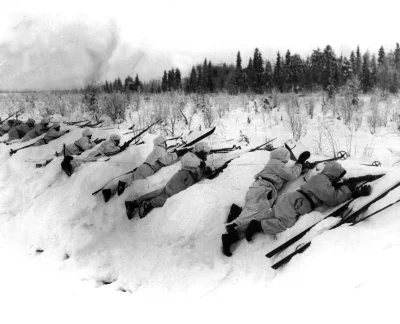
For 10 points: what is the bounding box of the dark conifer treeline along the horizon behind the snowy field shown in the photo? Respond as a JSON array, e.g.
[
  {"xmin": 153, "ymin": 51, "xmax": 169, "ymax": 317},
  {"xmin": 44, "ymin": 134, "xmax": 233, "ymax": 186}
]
[{"xmin": 94, "ymin": 43, "xmax": 400, "ymax": 94}]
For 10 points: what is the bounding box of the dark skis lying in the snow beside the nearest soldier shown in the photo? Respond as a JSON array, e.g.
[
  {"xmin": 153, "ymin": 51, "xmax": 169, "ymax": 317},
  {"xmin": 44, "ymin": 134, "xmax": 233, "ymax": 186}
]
[{"xmin": 266, "ymin": 175, "xmax": 400, "ymax": 270}]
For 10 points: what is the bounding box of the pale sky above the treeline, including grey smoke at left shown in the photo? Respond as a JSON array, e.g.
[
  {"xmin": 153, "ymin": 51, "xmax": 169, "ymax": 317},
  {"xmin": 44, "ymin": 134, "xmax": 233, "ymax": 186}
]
[{"xmin": 0, "ymin": 0, "xmax": 399, "ymax": 88}]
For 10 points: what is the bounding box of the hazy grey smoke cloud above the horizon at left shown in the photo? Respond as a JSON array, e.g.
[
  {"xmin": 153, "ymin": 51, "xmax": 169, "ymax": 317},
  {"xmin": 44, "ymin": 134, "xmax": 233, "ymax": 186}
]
[{"xmin": 0, "ymin": 18, "xmax": 119, "ymax": 90}]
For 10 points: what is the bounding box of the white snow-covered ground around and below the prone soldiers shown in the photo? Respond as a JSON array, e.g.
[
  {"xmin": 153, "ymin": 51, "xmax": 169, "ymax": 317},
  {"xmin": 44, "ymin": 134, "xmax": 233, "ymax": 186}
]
[{"xmin": 0, "ymin": 99, "xmax": 400, "ymax": 323}]
